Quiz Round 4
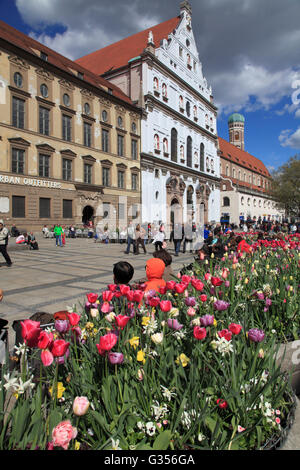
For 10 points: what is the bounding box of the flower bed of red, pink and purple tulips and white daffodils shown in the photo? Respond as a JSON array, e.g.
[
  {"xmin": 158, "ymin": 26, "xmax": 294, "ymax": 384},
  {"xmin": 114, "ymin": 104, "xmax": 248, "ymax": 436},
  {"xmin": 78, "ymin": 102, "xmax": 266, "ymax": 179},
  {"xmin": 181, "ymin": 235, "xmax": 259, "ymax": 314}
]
[{"xmin": 0, "ymin": 237, "xmax": 299, "ymax": 450}]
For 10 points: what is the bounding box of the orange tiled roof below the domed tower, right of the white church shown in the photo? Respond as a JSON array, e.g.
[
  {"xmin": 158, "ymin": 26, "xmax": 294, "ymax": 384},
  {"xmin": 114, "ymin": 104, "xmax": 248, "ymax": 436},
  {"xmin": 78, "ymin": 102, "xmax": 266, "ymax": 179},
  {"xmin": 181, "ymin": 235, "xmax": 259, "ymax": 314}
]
[{"xmin": 218, "ymin": 137, "xmax": 271, "ymax": 178}]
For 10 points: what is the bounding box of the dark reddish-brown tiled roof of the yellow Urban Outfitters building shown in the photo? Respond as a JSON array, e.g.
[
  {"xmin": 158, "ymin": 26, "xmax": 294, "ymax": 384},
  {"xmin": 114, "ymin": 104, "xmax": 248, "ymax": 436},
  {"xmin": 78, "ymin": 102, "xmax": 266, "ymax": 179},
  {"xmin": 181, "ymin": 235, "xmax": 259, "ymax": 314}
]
[{"xmin": 0, "ymin": 20, "xmax": 133, "ymax": 104}]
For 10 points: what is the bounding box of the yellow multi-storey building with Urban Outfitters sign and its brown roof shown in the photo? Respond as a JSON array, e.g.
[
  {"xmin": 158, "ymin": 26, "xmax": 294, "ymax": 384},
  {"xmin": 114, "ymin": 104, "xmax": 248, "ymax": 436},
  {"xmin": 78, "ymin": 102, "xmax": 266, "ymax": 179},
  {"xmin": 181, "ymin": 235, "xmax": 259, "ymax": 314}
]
[{"xmin": 0, "ymin": 22, "xmax": 141, "ymax": 230}]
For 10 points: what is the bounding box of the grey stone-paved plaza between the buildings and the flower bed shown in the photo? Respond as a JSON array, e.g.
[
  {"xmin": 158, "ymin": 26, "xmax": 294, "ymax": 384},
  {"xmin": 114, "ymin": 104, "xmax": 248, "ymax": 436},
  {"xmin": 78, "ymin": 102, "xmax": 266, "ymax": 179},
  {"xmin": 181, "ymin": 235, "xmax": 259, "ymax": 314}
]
[{"xmin": 0, "ymin": 237, "xmax": 193, "ymax": 347}]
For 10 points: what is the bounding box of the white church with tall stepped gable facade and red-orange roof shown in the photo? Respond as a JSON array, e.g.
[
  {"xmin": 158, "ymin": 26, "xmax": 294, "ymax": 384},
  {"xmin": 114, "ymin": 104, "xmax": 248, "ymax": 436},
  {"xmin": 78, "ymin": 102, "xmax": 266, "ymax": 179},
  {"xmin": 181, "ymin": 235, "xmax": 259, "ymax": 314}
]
[{"xmin": 77, "ymin": 1, "xmax": 221, "ymax": 232}]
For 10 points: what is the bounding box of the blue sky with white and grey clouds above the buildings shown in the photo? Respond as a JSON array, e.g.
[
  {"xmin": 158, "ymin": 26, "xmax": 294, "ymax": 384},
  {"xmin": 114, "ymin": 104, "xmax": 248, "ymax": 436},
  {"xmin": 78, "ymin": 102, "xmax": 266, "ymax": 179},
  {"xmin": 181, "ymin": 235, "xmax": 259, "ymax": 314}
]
[{"xmin": 0, "ymin": 0, "xmax": 300, "ymax": 170}]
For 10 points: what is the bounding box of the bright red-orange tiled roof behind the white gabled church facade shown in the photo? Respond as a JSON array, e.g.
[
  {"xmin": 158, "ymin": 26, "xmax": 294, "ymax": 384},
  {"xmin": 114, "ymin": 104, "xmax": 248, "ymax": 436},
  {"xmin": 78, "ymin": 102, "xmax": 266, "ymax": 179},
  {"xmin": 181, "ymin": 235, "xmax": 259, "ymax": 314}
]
[{"xmin": 76, "ymin": 16, "xmax": 181, "ymax": 75}]
